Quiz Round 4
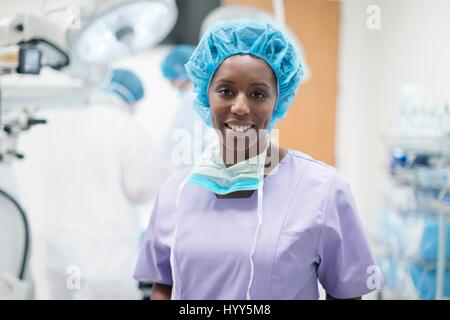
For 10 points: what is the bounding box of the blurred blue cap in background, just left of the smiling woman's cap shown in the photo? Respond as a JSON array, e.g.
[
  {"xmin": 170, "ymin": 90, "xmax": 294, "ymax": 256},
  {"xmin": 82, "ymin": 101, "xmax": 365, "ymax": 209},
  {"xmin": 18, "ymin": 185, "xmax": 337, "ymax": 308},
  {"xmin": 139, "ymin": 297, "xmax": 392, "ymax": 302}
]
[{"xmin": 161, "ymin": 45, "xmax": 195, "ymax": 80}]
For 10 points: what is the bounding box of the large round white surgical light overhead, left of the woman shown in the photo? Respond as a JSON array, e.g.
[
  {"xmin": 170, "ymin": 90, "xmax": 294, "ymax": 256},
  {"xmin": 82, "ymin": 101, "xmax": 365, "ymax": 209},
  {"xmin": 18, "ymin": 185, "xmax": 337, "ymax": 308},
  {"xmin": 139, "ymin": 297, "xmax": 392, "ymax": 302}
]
[{"xmin": 68, "ymin": 0, "xmax": 178, "ymax": 64}]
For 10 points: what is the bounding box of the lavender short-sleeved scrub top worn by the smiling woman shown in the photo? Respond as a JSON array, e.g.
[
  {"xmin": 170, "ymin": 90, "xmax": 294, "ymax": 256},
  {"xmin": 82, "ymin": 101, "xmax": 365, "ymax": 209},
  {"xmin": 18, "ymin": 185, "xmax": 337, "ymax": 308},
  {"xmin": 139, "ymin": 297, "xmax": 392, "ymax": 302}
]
[{"xmin": 134, "ymin": 150, "xmax": 374, "ymax": 300}]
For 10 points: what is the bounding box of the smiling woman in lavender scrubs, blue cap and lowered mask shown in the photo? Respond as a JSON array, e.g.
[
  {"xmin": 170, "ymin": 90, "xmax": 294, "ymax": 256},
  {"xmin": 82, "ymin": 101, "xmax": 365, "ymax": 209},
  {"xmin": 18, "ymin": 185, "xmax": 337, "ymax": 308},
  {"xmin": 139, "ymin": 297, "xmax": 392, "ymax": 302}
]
[{"xmin": 135, "ymin": 20, "xmax": 374, "ymax": 299}]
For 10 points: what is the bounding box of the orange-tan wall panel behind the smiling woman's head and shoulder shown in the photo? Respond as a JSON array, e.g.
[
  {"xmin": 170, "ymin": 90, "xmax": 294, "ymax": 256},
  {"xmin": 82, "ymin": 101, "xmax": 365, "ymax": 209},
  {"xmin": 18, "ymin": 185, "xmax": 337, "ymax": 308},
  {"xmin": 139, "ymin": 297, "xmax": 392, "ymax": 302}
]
[{"xmin": 224, "ymin": 0, "xmax": 340, "ymax": 165}]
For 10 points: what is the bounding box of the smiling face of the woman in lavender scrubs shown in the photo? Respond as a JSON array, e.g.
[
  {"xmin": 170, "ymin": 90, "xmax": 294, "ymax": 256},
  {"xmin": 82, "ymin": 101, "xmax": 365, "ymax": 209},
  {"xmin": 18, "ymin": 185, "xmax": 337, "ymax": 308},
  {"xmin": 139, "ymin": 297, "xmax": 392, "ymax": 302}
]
[{"xmin": 208, "ymin": 55, "xmax": 277, "ymax": 158}]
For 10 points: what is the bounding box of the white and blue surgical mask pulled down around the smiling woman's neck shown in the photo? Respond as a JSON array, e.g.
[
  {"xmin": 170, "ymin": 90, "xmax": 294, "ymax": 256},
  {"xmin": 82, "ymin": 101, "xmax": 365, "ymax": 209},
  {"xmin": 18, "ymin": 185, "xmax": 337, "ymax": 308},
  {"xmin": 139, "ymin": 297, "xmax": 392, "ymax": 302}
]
[{"xmin": 187, "ymin": 144, "xmax": 269, "ymax": 195}]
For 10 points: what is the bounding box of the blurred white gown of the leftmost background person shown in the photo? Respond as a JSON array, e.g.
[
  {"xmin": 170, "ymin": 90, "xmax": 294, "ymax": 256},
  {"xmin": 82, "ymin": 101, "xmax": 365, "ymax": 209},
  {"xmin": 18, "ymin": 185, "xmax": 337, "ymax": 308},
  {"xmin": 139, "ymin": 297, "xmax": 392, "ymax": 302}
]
[{"xmin": 21, "ymin": 98, "xmax": 167, "ymax": 299}]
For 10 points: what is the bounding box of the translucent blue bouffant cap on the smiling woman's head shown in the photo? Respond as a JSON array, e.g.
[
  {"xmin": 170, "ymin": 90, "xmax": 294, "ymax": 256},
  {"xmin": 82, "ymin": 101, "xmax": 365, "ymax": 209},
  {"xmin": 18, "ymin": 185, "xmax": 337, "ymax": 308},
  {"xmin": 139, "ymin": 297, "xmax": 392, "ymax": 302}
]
[{"xmin": 186, "ymin": 19, "xmax": 303, "ymax": 129}]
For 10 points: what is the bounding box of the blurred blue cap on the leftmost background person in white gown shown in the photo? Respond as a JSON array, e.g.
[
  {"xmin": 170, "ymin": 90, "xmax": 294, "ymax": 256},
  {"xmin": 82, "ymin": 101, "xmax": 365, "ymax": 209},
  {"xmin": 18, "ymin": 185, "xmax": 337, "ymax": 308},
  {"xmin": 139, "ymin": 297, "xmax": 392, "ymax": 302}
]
[{"xmin": 107, "ymin": 69, "xmax": 144, "ymax": 104}]
